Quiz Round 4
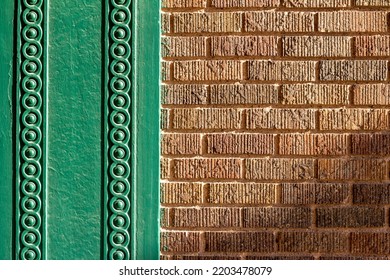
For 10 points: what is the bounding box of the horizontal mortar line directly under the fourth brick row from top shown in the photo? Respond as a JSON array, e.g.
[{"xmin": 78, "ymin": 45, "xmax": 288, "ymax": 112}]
[{"xmin": 162, "ymin": 79, "xmax": 389, "ymax": 86}]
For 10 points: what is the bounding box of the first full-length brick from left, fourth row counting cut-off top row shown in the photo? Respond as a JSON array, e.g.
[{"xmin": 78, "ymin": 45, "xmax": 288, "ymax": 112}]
[{"xmin": 173, "ymin": 60, "xmax": 243, "ymax": 81}]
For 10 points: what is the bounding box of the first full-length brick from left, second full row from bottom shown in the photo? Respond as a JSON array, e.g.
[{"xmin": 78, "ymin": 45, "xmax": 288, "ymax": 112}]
[{"xmin": 169, "ymin": 207, "xmax": 241, "ymax": 228}]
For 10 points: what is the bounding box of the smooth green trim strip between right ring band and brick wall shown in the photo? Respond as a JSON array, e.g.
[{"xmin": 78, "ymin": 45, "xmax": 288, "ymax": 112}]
[{"xmin": 132, "ymin": 0, "xmax": 161, "ymax": 260}]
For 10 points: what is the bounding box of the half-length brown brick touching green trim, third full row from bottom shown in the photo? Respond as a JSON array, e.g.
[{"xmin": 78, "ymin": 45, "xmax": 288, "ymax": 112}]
[{"xmin": 160, "ymin": 183, "xmax": 202, "ymax": 204}]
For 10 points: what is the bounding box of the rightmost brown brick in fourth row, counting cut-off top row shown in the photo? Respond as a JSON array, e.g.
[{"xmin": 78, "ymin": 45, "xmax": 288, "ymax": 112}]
[{"xmin": 320, "ymin": 60, "xmax": 387, "ymax": 81}]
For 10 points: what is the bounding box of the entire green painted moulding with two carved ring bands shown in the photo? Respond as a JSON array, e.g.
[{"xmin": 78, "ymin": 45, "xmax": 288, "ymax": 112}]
[{"xmin": 0, "ymin": 0, "xmax": 160, "ymax": 260}]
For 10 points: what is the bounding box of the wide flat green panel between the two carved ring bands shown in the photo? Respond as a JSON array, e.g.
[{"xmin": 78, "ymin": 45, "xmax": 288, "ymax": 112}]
[{"xmin": 47, "ymin": 0, "xmax": 103, "ymax": 259}]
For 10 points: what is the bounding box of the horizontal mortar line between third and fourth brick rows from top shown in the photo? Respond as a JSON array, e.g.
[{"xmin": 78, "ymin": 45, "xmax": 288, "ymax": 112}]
[{"xmin": 163, "ymin": 54, "xmax": 390, "ymax": 60}]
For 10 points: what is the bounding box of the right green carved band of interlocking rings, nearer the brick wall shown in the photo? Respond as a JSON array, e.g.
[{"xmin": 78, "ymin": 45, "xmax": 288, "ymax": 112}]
[{"xmin": 105, "ymin": 0, "xmax": 131, "ymax": 260}]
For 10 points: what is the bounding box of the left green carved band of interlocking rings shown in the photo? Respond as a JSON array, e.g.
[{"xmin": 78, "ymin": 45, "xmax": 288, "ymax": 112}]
[{"xmin": 16, "ymin": 0, "xmax": 45, "ymax": 260}]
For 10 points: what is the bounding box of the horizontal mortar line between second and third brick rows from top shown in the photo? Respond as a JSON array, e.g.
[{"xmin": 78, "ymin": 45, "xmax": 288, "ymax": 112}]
[{"xmin": 161, "ymin": 30, "xmax": 390, "ymax": 38}]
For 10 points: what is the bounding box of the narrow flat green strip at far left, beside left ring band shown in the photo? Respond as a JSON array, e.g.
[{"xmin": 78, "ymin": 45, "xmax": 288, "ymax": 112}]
[{"xmin": 0, "ymin": 1, "xmax": 15, "ymax": 260}]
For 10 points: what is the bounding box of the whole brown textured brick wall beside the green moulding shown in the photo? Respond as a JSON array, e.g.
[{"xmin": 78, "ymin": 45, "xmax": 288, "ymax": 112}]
[{"xmin": 161, "ymin": 0, "xmax": 390, "ymax": 259}]
